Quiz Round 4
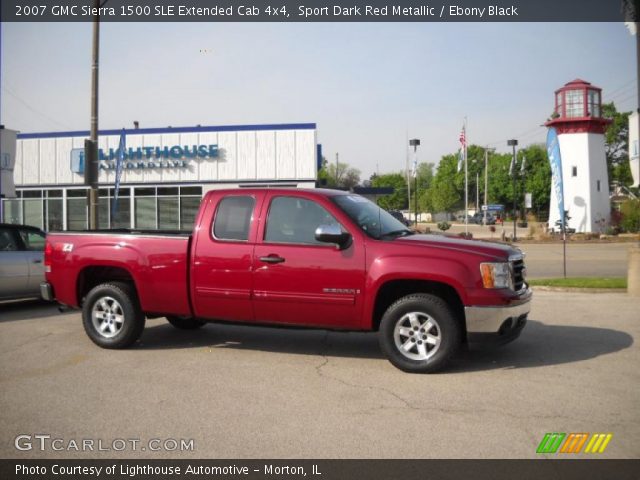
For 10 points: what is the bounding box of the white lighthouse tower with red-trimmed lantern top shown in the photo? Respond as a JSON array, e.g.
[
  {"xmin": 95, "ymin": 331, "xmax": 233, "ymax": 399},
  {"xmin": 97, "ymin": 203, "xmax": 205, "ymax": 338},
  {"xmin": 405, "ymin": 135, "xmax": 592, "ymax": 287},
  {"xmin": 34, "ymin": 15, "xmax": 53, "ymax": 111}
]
[{"xmin": 545, "ymin": 79, "xmax": 611, "ymax": 233}]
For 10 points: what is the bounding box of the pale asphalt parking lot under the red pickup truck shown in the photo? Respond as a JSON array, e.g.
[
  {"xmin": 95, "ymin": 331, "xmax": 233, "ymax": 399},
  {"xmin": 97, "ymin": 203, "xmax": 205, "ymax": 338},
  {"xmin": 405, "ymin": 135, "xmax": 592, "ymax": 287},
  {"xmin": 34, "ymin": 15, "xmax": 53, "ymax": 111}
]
[{"xmin": 0, "ymin": 292, "xmax": 640, "ymax": 459}]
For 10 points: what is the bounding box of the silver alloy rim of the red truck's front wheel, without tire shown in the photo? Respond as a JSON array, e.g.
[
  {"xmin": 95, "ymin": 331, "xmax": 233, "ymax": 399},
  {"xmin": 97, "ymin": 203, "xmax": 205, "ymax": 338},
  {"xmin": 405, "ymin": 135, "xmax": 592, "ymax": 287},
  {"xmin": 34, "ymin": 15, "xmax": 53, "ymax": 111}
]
[{"xmin": 393, "ymin": 312, "xmax": 442, "ymax": 360}]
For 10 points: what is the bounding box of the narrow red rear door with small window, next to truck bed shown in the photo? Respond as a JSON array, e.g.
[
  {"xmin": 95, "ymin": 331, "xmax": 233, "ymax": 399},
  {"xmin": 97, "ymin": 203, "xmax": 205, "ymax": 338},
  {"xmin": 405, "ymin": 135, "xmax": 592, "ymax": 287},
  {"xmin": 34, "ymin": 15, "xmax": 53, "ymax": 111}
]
[{"xmin": 191, "ymin": 190, "xmax": 264, "ymax": 321}]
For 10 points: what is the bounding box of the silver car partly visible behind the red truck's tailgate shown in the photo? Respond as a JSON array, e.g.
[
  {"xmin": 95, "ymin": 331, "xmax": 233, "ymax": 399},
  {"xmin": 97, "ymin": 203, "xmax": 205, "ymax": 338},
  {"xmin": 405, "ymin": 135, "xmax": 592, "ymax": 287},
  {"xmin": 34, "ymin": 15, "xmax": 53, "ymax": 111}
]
[{"xmin": 0, "ymin": 223, "xmax": 45, "ymax": 300}]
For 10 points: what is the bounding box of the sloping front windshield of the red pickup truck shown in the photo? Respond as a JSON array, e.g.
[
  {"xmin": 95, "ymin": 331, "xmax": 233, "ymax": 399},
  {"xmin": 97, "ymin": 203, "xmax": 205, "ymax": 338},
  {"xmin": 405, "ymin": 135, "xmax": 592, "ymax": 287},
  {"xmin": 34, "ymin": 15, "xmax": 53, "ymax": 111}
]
[{"xmin": 332, "ymin": 195, "xmax": 413, "ymax": 240}]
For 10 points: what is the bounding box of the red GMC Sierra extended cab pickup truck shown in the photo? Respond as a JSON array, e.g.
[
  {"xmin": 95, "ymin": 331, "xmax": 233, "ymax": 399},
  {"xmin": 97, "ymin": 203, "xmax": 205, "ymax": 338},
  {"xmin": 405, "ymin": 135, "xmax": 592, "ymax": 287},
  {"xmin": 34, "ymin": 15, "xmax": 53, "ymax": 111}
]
[{"xmin": 41, "ymin": 188, "xmax": 531, "ymax": 372}]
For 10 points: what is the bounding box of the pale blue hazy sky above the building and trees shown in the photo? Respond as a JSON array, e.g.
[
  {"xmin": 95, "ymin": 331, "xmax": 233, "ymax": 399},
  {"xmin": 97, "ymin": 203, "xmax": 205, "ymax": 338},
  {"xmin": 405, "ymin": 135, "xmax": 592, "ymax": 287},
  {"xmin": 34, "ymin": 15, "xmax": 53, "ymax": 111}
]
[{"xmin": 0, "ymin": 23, "xmax": 637, "ymax": 180}]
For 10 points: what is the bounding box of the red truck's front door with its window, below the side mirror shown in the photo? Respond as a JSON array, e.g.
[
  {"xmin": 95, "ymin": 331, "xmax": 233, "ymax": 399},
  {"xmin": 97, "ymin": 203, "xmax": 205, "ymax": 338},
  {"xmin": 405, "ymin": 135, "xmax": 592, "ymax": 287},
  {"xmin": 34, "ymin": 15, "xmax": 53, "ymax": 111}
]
[{"xmin": 253, "ymin": 191, "xmax": 365, "ymax": 329}]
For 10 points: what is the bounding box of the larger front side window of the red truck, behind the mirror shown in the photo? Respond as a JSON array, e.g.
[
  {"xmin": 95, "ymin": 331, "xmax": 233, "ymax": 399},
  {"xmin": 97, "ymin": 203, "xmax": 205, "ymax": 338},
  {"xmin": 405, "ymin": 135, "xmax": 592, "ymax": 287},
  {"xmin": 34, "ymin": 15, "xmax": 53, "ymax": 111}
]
[{"xmin": 264, "ymin": 197, "xmax": 342, "ymax": 246}]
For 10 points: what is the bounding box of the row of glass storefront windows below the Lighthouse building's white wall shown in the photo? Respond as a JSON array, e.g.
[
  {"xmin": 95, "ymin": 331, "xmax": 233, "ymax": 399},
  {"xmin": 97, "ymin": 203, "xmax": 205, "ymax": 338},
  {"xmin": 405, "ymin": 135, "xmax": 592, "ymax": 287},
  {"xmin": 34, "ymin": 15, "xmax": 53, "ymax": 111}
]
[{"xmin": 2, "ymin": 186, "xmax": 202, "ymax": 231}]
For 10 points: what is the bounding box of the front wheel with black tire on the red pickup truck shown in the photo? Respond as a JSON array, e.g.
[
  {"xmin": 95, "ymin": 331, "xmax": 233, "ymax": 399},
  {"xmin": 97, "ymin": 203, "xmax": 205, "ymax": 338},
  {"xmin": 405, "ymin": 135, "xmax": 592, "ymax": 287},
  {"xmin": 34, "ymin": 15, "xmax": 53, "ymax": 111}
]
[{"xmin": 378, "ymin": 293, "xmax": 462, "ymax": 373}]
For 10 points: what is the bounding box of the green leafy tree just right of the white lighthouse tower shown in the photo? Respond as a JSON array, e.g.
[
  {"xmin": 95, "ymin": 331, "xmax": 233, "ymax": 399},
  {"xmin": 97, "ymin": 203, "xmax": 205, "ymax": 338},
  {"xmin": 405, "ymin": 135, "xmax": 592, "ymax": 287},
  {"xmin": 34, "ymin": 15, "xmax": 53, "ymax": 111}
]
[{"xmin": 602, "ymin": 102, "xmax": 633, "ymax": 186}]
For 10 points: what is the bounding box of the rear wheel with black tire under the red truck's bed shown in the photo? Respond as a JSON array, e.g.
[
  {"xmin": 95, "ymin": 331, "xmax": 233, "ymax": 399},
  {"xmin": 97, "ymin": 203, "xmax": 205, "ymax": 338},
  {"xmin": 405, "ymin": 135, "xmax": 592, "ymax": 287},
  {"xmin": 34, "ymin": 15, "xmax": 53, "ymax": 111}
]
[{"xmin": 82, "ymin": 282, "xmax": 145, "ymax": 349}]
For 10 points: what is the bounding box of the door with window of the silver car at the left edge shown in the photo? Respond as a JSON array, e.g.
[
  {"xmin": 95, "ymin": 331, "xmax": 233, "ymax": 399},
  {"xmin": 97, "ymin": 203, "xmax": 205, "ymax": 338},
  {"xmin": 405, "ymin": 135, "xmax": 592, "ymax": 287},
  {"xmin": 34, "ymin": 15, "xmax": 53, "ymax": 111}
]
[{"xmin": 0, "ymin": 226, "xmax": 29, "ymax": 298}]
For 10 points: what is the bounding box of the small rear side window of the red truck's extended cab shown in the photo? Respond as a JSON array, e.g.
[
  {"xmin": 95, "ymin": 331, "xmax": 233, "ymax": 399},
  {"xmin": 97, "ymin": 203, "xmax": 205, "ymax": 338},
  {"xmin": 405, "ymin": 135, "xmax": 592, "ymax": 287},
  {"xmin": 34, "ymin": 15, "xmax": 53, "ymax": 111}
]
[{"xmin": 213, "ymin": 196, "xmax": 255, "ymax": 242}]
